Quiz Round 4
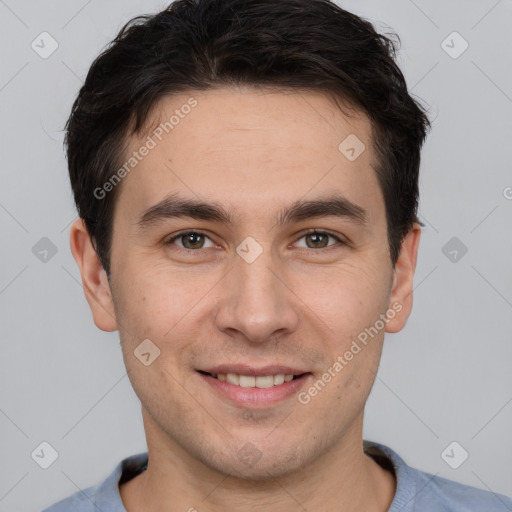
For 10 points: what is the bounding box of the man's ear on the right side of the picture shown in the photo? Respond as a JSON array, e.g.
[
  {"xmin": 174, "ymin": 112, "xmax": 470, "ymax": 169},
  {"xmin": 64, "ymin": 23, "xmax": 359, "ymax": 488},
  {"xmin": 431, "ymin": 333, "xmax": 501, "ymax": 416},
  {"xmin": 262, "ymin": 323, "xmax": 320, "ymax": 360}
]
[{"xmin": 386, "ymin": 222, "xmax": 421, "ymax": 332}]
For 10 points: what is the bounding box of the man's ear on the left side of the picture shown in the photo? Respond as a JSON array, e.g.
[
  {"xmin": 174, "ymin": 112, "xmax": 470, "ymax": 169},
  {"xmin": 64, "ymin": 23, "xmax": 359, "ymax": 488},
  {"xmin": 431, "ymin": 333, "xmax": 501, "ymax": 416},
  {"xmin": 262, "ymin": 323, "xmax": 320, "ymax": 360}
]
[{"xmin": 70, "ymin": 219, "xmax": 117, "ymax": 331}]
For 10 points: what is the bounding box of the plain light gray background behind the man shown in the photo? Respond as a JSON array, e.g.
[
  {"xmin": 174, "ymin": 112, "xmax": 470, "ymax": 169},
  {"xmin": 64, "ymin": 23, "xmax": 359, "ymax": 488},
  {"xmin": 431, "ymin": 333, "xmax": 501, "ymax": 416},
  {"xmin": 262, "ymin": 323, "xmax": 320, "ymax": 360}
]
[{"xmin": 0, "ymin": 0, "xmax": 512, "ymax": 512}]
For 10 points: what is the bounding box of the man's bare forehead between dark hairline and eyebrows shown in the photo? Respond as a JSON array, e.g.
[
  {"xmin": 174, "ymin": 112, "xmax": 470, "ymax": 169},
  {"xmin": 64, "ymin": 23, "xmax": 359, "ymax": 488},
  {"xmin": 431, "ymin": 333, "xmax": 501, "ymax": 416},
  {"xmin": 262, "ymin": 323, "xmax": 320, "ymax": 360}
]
[{"xmin": 116, "ymin": 88, "xmax": 384, "ymax": 227}]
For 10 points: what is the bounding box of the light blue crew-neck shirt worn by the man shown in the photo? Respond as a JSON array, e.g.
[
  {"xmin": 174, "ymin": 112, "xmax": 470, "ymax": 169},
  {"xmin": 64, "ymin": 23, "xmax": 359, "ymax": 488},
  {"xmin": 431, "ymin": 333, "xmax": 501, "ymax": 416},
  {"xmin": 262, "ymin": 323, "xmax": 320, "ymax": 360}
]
[{"xmin": 43, "ymin": 441, "xmax": 512, "ymax": 512}]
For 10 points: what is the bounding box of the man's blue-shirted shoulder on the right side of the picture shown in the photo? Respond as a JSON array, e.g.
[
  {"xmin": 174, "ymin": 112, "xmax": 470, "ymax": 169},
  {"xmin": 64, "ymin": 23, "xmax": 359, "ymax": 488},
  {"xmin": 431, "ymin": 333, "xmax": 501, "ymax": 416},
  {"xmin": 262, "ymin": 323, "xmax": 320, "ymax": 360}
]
[{"xmin": 364, "ymin": 441, "xmax": 512, "ymax": 512}]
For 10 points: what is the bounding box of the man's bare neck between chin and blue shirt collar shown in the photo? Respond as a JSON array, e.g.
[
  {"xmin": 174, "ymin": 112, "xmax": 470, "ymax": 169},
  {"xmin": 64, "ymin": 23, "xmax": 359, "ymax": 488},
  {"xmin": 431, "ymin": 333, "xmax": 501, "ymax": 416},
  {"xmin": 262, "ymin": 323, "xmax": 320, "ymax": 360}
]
[{"xmin": 119, "ymin": 414, "xmax": 396, "ymax": 512}]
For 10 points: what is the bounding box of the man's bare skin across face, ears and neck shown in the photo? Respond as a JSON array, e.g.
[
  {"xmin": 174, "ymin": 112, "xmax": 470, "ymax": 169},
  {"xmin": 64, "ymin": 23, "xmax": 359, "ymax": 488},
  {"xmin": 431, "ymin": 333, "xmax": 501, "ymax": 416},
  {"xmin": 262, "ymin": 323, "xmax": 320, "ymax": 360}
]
[{"xmin": 71, "ymin": 87, "xmax": 421, "ymax": 512}]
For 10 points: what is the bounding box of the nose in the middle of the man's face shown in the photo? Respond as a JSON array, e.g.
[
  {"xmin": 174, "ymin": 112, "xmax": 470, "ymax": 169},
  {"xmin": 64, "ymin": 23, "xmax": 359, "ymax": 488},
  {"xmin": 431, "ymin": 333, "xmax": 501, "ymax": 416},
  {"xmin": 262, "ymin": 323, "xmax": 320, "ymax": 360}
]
[{"xmin": 216, "ymin": 245, "xmax": 299, "ymax": 343}]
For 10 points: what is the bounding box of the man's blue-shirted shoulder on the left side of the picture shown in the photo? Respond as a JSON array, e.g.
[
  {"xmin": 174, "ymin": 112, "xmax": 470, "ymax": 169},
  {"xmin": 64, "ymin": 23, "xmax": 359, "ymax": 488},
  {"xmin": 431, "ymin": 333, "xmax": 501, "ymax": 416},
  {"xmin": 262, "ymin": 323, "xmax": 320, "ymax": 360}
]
[{"xmin": 42, "ymin": 452, "xmax": 148, "ymax": 512}]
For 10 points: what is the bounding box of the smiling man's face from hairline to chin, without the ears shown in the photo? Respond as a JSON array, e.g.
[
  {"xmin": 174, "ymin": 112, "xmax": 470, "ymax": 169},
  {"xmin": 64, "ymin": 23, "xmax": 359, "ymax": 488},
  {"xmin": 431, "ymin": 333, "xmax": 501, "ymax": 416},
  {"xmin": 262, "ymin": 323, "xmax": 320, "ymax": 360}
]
[{"xmin": 89, "ymin": 88, "xmax": 416, "ymax": 479}]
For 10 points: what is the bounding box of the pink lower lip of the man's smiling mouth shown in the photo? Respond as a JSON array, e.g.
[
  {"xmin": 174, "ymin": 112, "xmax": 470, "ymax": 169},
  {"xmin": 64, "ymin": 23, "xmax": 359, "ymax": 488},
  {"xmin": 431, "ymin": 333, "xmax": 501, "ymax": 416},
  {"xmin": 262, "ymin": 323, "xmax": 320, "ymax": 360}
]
[{"xmin": 198, "ymin": 372, "xmax": 311, "ymax": 408}]
